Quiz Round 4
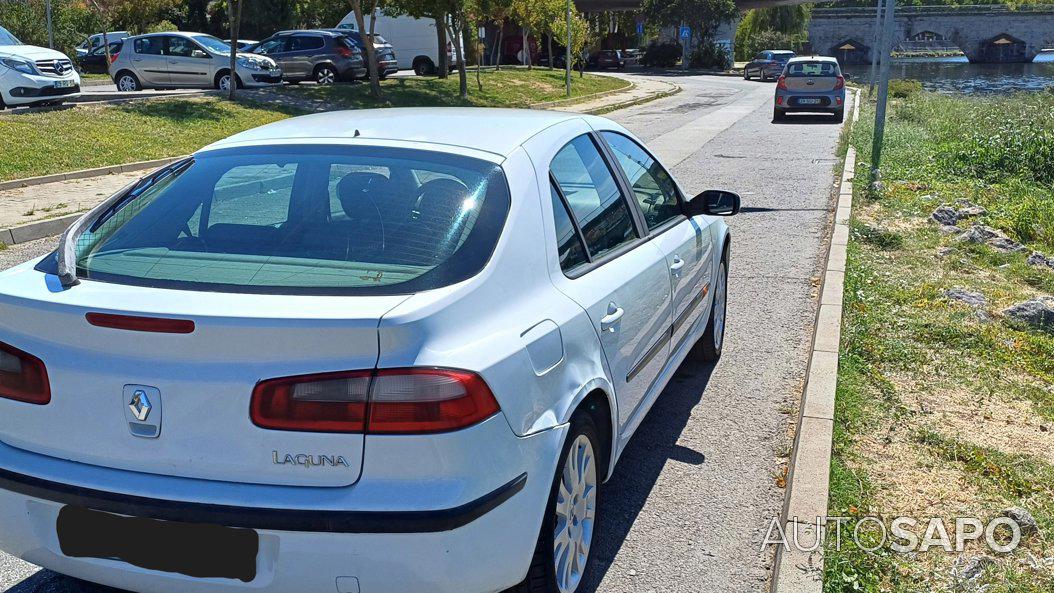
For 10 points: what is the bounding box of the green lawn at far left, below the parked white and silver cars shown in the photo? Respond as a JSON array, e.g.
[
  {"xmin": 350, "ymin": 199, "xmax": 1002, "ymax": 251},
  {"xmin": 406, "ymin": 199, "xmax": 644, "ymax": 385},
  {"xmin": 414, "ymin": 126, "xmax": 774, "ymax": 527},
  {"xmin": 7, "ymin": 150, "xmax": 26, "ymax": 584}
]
[{"xmin": 0, "ymin": 98, "xmax": 296, "ymax": 180}]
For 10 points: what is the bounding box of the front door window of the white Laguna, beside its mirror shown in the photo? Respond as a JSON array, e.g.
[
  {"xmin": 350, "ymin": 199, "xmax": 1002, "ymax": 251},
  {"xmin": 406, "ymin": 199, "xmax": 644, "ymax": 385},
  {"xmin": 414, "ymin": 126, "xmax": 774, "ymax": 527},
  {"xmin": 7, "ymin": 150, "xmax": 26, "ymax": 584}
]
[{"xmin": 601, "ymin": 132, "xmax": 681, "ymax": 229}]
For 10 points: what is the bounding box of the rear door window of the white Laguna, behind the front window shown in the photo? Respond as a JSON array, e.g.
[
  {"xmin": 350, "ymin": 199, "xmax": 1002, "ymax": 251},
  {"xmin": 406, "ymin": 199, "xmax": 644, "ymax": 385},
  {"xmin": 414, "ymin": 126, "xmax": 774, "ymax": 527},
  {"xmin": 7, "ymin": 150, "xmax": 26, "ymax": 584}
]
[{"xmin": 550, "ymin": 135, "xmax": 637, "ymax": 259}]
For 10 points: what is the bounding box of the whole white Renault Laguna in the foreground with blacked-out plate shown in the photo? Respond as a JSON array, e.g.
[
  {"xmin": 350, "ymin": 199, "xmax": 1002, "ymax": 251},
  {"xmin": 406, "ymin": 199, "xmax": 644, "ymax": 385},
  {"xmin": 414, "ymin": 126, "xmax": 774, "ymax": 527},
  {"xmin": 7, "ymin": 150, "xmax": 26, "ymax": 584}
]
[{"xmin": 0, "ymin": 108, "xmax": 739, "ymax": 593}]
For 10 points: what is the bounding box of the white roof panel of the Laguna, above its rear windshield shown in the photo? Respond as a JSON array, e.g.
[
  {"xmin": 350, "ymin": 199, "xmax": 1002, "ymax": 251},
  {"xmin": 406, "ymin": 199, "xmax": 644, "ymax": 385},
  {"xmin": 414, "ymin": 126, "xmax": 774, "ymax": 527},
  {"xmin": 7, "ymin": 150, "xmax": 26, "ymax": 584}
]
[{"xmin": 202, "ymin": 107, "xmax": 600, "ymax": 158}]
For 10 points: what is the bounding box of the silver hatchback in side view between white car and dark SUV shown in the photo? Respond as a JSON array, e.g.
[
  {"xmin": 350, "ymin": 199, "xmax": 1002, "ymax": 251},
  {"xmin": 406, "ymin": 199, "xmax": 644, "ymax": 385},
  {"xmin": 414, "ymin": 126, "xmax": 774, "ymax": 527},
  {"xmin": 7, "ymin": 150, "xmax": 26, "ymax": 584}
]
[{"xmin": 110, "ymin": 32, "xmax": 281, "ymax": 92}]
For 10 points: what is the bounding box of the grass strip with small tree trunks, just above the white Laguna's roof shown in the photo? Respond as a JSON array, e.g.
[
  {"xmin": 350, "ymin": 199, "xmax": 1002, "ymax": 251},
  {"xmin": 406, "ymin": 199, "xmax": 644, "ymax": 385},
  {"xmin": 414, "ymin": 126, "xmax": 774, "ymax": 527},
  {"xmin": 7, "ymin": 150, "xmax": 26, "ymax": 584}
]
[{"xmin": 271, "ymin": 67, "xmax": 629, "ymax": 108}]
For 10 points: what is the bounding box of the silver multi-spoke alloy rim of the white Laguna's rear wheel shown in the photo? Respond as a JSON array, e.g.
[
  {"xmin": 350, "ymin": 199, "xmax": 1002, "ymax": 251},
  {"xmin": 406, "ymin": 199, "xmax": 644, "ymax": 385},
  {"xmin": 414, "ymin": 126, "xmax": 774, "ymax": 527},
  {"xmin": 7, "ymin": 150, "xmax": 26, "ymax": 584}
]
[{"xmin": 552, "ymin": 435, "xmax": 597, "ymax": 593}]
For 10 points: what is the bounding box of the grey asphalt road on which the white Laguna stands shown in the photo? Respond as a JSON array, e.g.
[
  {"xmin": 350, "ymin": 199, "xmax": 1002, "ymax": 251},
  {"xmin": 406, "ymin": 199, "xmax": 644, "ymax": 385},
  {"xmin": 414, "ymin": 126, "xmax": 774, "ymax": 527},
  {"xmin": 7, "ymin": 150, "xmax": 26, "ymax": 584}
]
[{"xmin": 0, "ymin": 76, "xmax": 840, "ymax": 593}]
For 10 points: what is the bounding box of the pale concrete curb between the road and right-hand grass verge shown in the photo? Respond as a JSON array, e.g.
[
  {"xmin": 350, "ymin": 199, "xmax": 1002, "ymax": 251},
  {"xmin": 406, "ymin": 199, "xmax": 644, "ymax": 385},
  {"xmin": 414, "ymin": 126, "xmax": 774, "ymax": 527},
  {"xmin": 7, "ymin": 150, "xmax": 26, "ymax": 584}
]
[{"xmin": 772, "ymin": 87, "xmax": 860, "ymax": 593}]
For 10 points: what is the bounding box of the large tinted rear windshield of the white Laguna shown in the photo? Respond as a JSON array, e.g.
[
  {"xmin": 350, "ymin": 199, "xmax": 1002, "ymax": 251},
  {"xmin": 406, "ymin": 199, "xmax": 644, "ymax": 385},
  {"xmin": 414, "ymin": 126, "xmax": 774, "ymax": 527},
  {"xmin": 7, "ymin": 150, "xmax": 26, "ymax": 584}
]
[{"xmin": 71, "ymin": 145, "xmax": 509, "ymax": 295}]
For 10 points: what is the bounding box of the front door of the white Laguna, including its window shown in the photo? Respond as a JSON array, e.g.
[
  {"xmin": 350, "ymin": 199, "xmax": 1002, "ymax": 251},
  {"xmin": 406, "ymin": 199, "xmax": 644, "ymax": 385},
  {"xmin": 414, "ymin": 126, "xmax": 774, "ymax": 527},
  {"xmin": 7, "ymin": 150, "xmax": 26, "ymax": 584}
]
[{"xmin": 601, "ymin": 131, "xmax": 713, "ymax": 353}]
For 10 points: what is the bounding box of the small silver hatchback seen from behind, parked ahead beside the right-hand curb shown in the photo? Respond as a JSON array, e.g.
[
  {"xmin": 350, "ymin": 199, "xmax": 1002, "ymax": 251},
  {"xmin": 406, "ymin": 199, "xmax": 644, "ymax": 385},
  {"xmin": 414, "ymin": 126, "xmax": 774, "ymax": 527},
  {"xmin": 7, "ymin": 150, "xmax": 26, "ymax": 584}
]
[{"xmin": 773, "ymin": 56, "xmax": 845, "ymax": 122}]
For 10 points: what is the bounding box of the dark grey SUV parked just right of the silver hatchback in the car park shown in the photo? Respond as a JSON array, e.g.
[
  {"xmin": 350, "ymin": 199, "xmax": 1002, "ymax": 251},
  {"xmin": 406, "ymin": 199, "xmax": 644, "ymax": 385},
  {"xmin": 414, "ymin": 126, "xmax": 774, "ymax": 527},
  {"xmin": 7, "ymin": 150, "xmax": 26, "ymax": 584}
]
[{"xmin": 251, "ymin": 31, "xmax": 367, "ymax": 84}]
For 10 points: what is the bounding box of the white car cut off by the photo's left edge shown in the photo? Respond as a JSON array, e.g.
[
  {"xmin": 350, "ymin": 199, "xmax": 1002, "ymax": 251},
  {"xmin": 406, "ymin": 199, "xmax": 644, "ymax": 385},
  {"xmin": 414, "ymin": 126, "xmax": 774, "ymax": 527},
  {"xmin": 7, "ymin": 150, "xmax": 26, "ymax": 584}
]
[{"xmin": 0, "ymin": 26, "xmax": 80, "ymax": 110}]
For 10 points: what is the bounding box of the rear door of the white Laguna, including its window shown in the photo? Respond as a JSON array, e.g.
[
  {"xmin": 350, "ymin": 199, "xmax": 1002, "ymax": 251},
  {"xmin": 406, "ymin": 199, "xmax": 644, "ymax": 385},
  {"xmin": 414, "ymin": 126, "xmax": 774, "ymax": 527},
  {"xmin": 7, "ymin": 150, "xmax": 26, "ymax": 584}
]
[{"xmin": 549, "ymin": 134, "xmax": 670, "ymax": 427}]
